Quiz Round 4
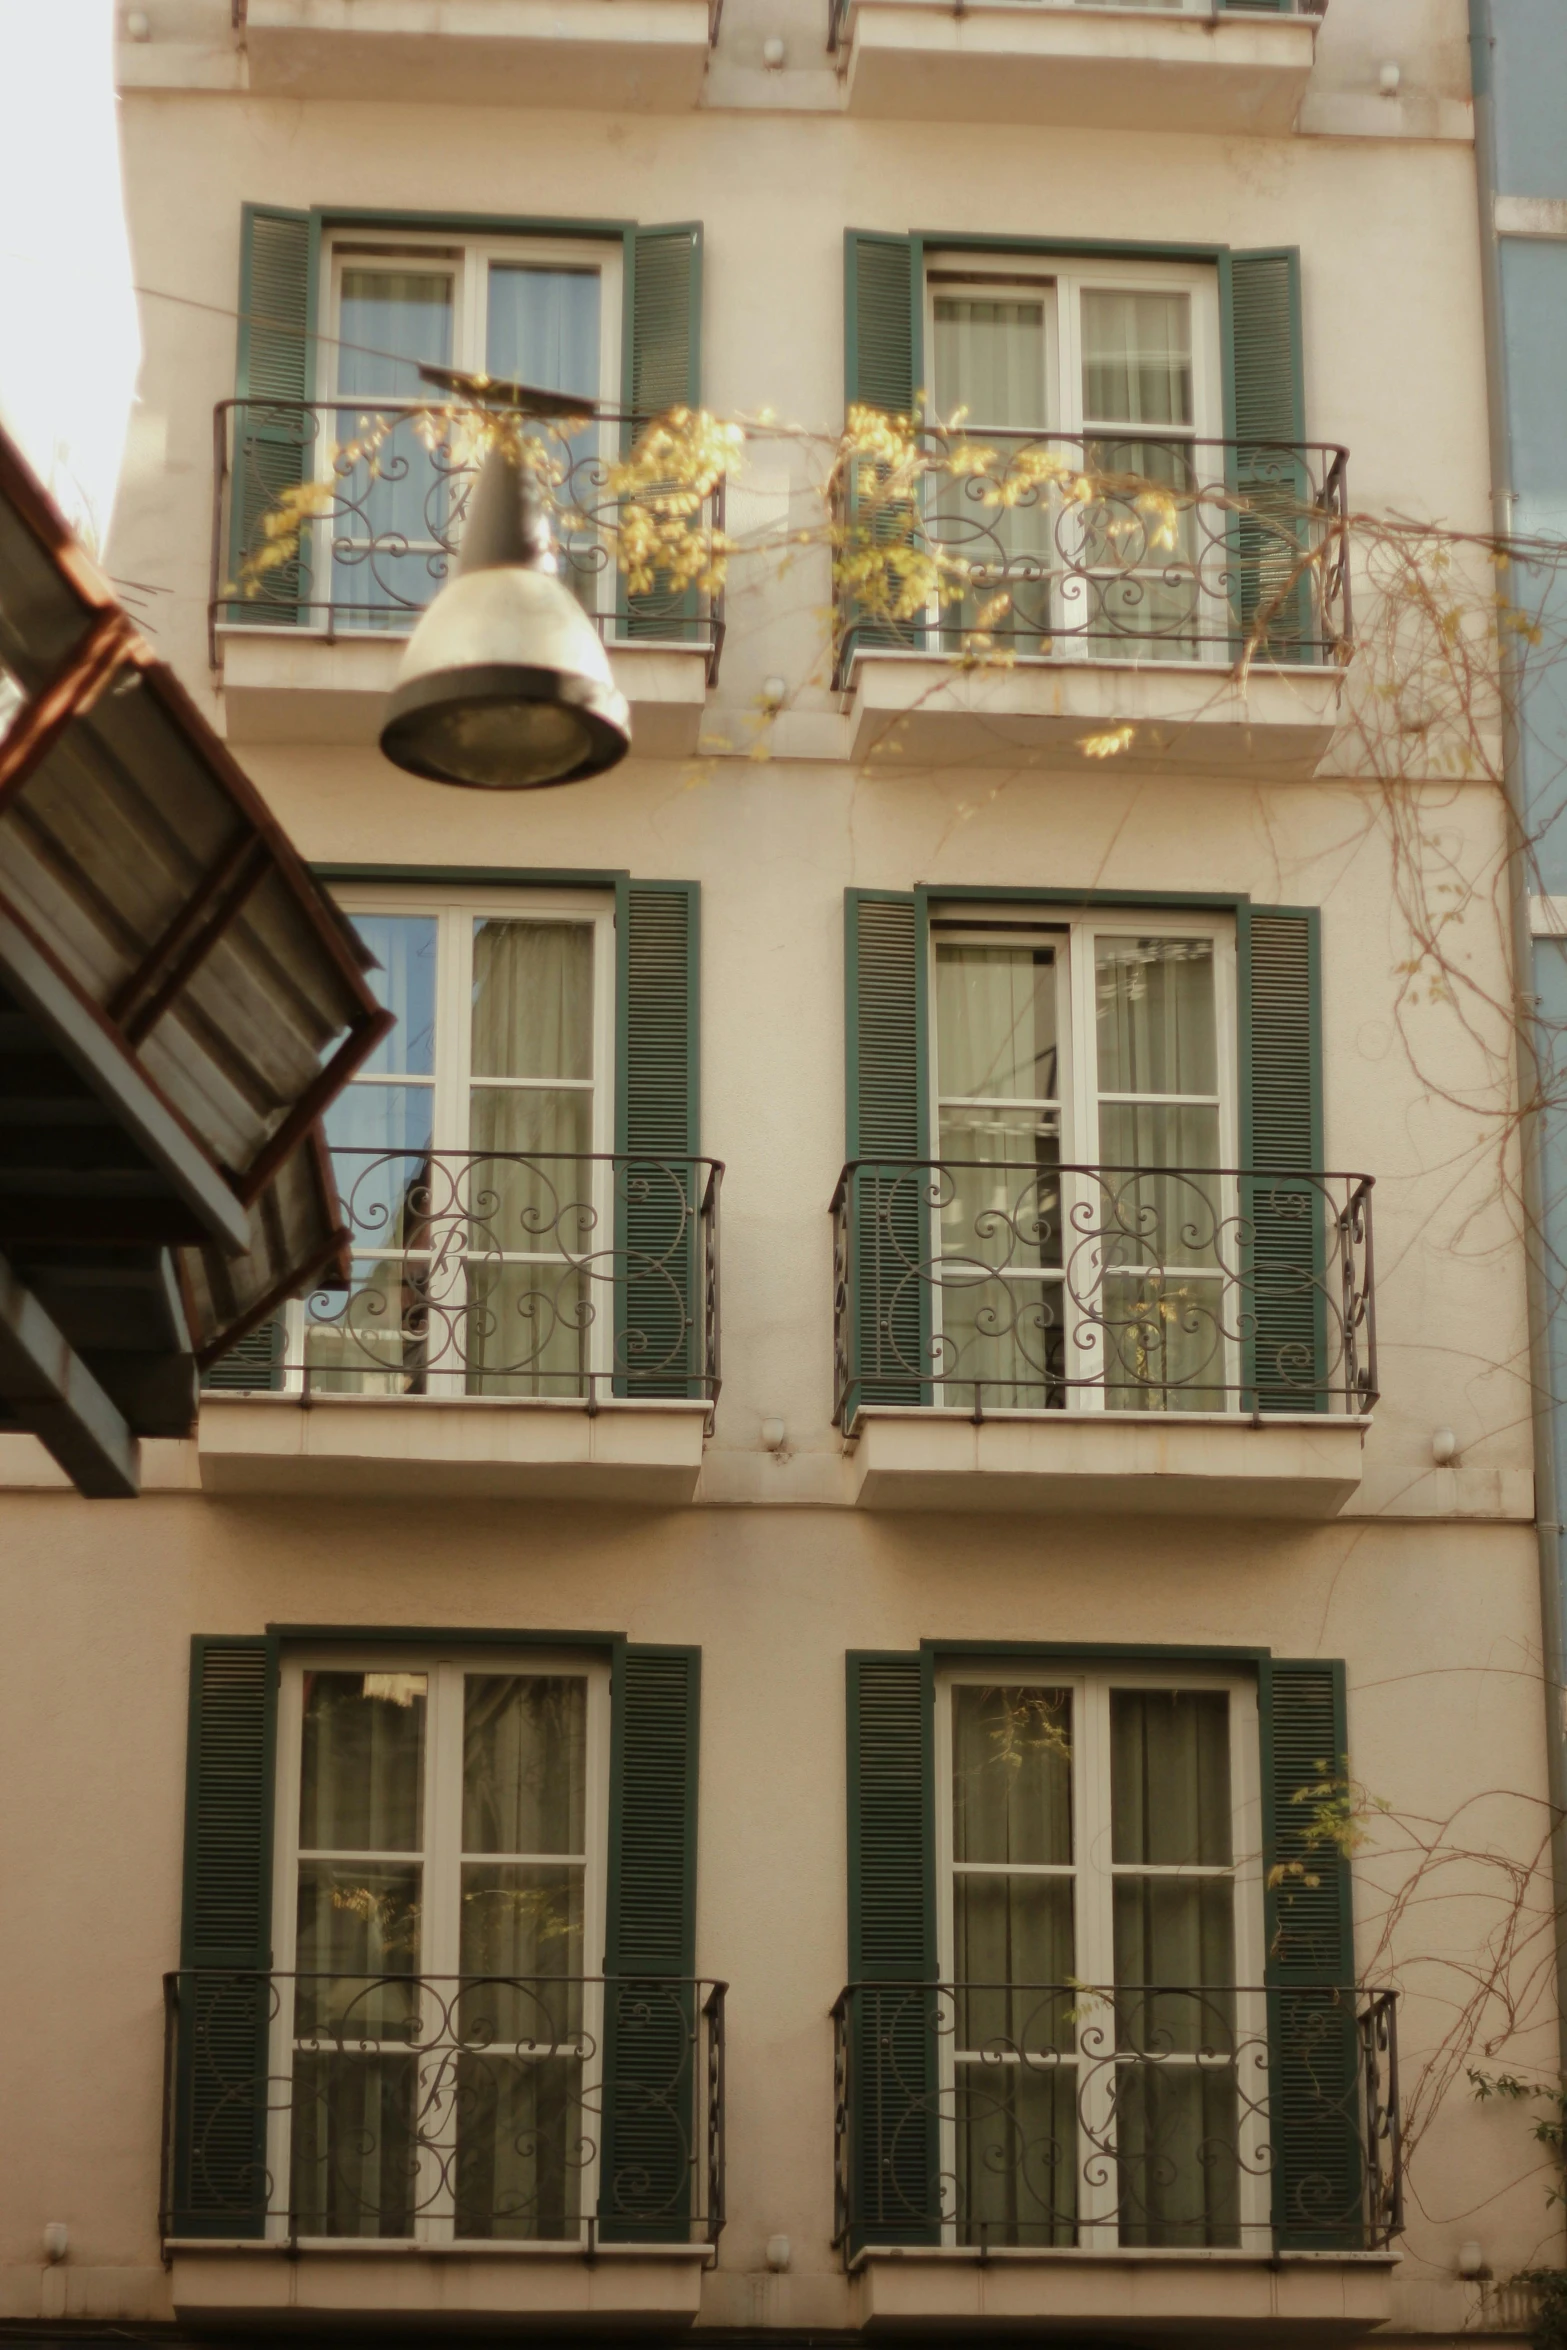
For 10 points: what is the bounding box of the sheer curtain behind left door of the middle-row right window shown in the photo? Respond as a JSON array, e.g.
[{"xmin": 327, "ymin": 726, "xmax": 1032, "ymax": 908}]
[{"xmin": 935, "ymin": 940, "xmax": 1064, "ymax": 1408}]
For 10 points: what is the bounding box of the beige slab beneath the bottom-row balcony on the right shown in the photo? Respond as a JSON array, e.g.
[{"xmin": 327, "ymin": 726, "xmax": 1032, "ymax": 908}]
[{"xmin": 858, "ymin": 2249, "xmax": 1395, "ymax": 2345}]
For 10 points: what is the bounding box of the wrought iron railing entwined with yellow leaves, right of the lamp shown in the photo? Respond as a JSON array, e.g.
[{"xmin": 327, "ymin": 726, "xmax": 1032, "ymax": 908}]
[{"xmin": 836, "ymin": 425, "xmax": 1351, "ymax": 684}]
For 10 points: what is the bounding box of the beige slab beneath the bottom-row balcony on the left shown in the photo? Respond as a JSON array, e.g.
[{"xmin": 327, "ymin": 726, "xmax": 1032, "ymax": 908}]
[{"xmin": 172, "ymin": 2244, "xmax": 712, "ymax": 2331}]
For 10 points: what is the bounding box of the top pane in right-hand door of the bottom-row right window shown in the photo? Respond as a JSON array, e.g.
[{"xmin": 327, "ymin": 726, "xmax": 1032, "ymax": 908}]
[{"xmin": 1109, "ymin": 1690, "xmax": 1233, "ymax": 1868}]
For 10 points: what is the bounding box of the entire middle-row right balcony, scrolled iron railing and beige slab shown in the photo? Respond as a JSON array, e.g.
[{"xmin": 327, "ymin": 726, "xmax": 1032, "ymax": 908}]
[{"xmin": 832, "ymin": 1159, "xmax": 1377, "ymax": 1518}]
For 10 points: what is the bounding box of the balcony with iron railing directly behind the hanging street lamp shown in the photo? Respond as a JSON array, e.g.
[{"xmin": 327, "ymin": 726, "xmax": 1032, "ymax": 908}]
[{"xmin": 207, "ymin": 401, "xmax": 724, "ymax": 759}]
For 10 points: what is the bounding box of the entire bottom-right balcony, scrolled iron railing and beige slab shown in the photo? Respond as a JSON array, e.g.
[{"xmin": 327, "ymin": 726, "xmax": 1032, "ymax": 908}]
[{"xmin": 832, "ymin": 1983, "xmax": 1403, "ymax": 2343}]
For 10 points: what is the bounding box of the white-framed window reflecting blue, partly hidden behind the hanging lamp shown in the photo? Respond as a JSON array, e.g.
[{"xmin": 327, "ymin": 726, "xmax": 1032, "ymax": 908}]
[{"xmin": 317, "ymin": 228, "xmax": 623, "ymax": 630}]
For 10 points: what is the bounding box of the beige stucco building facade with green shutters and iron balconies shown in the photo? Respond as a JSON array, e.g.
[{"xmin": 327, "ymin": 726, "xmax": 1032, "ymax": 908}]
[{"xmin": 0, "ymin": 0, "xmax": 1560, "ymax": 2345}]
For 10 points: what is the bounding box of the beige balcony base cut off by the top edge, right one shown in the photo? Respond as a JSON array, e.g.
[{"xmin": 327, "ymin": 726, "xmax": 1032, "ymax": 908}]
[{"xmin": 827, "ymin": 0, "xmax": 1325, "ymax": 136}]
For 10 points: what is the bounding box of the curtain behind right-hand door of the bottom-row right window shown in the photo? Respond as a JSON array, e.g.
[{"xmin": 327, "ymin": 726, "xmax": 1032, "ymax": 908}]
[{"xmin": 1111, "ymin": 1690, "xmax": 1240, "ymax": 2247}]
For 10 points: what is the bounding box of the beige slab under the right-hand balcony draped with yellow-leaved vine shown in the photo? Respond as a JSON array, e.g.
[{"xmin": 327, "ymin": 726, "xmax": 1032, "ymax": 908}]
[{"xmin": 850, "ymin": 653, "xmax": 1344, "ymax": 780}]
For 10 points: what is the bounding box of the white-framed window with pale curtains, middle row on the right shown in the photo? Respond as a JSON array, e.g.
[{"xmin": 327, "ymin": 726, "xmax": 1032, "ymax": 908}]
[{"xmin": 928, "ymin": 902, "xmax": 1240, "ymax": 1410}]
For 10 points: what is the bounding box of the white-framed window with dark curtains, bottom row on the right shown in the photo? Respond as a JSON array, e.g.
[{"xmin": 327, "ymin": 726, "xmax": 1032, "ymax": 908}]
[{"xmin": 935, "ymin": 1664, "xmax": 1273, "ymax": 2251}]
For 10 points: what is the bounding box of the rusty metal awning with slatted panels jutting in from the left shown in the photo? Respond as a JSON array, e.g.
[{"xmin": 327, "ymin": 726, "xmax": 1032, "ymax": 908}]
[{"xmin": 0, "ymin": 432, "xmax": 390, "ymax": 1495}]
